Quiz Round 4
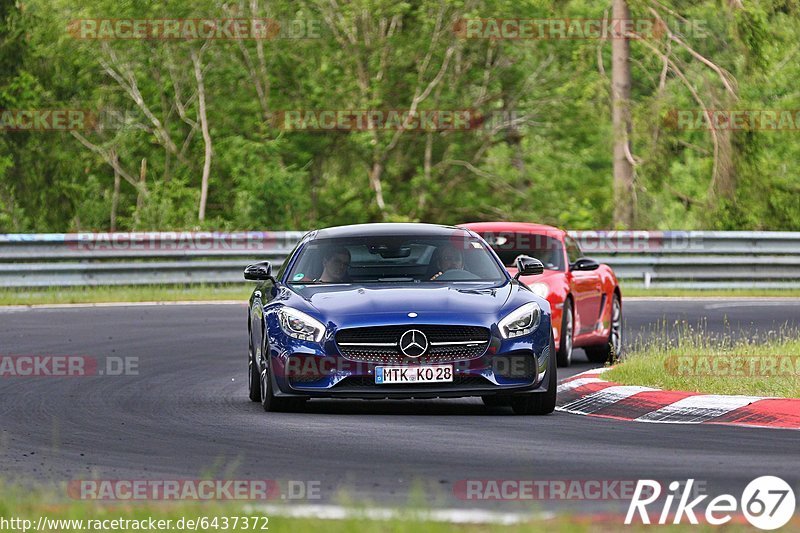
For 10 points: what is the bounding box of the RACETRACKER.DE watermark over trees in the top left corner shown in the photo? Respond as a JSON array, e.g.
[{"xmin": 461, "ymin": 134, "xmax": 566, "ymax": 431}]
[{"xmin": 67, "ymin": 18, "xmax": 323, "ymax": 41}]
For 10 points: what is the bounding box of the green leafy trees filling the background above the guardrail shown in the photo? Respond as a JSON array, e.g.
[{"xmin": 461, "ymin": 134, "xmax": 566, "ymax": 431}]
[{"xmin": 0, "ymin": 0, "xmax": 800, "ymax": 232}]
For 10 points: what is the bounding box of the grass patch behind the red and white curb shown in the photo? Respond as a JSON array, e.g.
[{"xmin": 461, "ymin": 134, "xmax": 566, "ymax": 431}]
[{"xmin": 604, "ymin": 331, "xmax": 800, "ymax": 398}]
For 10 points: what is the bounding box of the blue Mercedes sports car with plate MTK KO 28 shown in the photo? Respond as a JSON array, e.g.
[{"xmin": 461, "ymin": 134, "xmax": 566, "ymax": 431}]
[{"xmin": 244, "ymin": 224, "xmax": 556, "ymax": 414}]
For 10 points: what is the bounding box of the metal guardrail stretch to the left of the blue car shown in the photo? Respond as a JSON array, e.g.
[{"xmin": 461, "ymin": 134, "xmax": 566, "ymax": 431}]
[{"xmin": 0, "ymin": 231, "xmax": 305, "ymax": 287}]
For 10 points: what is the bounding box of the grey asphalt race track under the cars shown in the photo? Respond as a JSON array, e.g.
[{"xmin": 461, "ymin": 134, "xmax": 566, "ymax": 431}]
[{"xmin": 0, "ymin": 300, "xmax": 800, "ymax": 510}]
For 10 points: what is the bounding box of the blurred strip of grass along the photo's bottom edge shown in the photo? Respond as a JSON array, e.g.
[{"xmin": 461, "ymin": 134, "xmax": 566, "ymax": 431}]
[{"xmin": 0, "ymin": 483, "xmax": 780, "ymax": 533}]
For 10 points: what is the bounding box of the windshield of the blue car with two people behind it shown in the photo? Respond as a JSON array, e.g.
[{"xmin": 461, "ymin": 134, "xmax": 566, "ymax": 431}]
[{"xmin": 285, "ymin": 235, "xmax": 507, "ymax": 284}]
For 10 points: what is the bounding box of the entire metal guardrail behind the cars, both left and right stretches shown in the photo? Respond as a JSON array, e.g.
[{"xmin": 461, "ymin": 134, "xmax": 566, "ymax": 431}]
[{"xmin": 0, "ymin": 231, "xmax": 800, "ymax": 289}]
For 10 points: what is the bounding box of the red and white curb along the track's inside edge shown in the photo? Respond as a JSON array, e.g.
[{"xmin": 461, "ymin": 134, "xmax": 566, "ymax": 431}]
[{"xmin": 556, "ymin": 368, "xmax": 800, "ymax": 429}]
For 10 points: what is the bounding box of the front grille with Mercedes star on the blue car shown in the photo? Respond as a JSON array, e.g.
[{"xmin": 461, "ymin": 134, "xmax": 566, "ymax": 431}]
[{"xmin": 336, "ymin": 325, "xmax": 490, "ymax": 364}]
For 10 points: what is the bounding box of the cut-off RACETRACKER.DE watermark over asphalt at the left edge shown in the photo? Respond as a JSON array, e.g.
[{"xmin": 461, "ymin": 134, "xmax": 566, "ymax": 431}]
[{"xmin": 0, "ymin": 355, "xmax": 139, "ymax": 378}]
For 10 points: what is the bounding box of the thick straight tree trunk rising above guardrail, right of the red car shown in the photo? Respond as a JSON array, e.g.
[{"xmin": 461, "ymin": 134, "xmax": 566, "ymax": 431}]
[{"xmin": 611, "ymin": 0, "xmax": 636, "ymax": 228}]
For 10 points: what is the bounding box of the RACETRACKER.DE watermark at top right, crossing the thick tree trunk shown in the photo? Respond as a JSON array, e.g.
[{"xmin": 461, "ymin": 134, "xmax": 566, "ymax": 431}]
[{"xmin": 453, "ymin": 18, "xmax": 710, "ymax": 40}]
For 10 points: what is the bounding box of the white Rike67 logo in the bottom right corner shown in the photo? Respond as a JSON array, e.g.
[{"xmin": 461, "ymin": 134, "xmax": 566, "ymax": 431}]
[{"xmin": 625, "ymin": 476, "xmax": 795, "ymax": 530}]
